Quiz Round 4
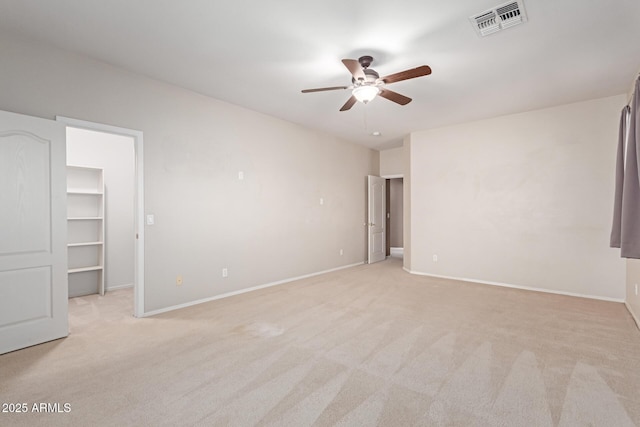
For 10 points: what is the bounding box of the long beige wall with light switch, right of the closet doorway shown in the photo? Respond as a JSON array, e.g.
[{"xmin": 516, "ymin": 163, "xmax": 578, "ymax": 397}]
[{"xmin": 0, "ymin": 37, "xmax": 379, "ymax": 312}]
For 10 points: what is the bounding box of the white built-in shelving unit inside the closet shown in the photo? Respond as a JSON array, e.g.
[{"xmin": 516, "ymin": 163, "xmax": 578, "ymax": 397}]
[{"xmin": 67, "ymin": 166, "xmax": 105, "ymax": 298}]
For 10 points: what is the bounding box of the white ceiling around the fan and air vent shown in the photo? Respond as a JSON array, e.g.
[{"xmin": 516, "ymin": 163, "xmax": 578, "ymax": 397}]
[{"xmin": 0, "ymin": 0, "xmax": 640, "ymax": 149}]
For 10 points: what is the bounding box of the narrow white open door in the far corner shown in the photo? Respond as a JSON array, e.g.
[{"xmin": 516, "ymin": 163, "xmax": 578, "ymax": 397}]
[{"xmin": 367, "ymin": 175, "xmax": 386, "ymax": 264}]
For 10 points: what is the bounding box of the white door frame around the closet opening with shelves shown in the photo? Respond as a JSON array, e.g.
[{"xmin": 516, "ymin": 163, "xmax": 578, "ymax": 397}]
[{"xmin": 56, "ymin": 116, "xmax": 145, "ymax": 317}]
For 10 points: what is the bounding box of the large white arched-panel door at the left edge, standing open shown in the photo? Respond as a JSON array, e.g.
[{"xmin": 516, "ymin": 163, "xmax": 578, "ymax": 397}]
[{"xmin": 0, "ymin": 111, "xmax": 69, "ymax": 354}]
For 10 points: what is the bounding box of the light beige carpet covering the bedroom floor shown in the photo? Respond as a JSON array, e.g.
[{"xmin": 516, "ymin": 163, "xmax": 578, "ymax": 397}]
[{"xmin": 0, "ymin": 259, "xmax": 640, "ymax": 426}]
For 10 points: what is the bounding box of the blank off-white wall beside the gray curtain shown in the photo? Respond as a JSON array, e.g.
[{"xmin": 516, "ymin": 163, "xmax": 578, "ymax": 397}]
[{"xmin": 405, "ymin": 95, "xmax": 626, "ymax": 300}]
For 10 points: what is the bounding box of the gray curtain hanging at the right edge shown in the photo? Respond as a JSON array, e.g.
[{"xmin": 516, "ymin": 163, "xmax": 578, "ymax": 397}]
[{"xmin": 611, "ymin": 79, "xmax": 640, "ymax": 258}]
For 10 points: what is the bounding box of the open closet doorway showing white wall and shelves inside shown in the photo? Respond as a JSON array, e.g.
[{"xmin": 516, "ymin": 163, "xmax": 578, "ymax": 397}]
[{"xmin": 67, "ymin": 127, "xmax": 135, "ymax": 298}]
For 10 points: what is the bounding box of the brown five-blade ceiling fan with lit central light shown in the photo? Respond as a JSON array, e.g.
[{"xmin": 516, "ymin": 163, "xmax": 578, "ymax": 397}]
[{"xmin": 302, "ymin": 56, "xmax": 431, "ymax": 111}]
